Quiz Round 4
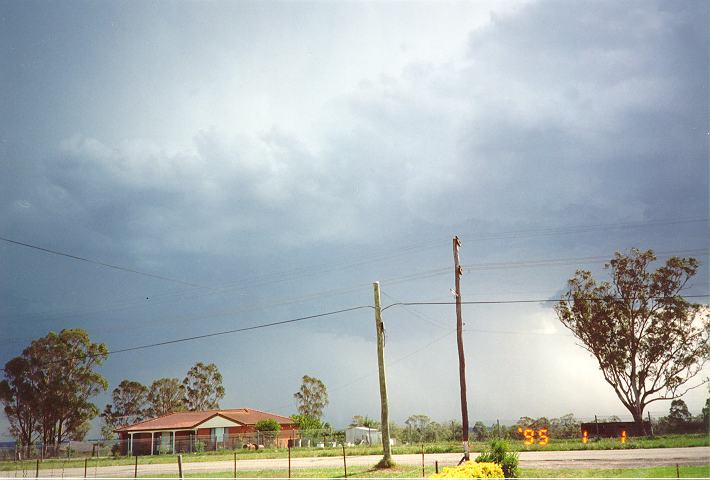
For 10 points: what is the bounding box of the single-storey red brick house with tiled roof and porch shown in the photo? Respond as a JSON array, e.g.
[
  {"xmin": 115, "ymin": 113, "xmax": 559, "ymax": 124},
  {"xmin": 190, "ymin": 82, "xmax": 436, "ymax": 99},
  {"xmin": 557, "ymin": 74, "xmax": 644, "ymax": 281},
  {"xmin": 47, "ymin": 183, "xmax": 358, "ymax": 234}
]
[{"xmin": 114, "ymin": 408, "xmax": 298, "ymax": 455}]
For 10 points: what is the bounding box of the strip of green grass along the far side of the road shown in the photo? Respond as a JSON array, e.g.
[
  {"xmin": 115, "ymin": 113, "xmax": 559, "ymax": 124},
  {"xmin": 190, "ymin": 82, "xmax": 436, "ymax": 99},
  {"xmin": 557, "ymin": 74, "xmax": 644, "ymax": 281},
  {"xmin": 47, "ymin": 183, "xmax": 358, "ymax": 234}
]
[{"xmin": 0, "ymin": 434, "xmax": 710, "ymax": 471}]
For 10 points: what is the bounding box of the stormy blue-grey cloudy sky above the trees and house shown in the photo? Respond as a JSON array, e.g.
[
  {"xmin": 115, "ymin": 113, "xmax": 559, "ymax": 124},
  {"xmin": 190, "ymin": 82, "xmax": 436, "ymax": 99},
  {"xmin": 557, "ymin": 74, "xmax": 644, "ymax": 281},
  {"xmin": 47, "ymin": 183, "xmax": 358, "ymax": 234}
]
[{"xmin": 0, "ymin": 0, "xmax": 710, "ymax": 438}]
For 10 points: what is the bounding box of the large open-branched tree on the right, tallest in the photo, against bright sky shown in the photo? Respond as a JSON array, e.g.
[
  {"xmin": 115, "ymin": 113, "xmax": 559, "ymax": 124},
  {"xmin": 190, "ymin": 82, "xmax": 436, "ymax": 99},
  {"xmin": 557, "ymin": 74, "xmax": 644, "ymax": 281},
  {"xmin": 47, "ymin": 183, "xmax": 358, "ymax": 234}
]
[{"xmin": 556, "ymin": 249, "xmax": 708, "ymax": 434}]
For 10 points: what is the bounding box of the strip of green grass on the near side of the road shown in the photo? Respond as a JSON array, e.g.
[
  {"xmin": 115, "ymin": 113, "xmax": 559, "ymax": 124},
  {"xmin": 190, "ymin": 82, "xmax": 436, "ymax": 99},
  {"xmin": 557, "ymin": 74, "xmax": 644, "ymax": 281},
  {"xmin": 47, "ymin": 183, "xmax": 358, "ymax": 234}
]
[{"xmin": 138, "ymin": 465, "xmax": 710, "ymax": 478}]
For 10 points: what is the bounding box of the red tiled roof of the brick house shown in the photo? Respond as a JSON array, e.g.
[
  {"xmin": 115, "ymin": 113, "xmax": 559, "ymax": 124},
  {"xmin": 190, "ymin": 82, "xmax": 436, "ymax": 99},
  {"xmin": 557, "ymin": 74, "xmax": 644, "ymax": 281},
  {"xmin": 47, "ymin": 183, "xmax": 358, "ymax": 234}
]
[{"xmin": 115, "ymin": 408, "xmax": 293, "ymax": 432}]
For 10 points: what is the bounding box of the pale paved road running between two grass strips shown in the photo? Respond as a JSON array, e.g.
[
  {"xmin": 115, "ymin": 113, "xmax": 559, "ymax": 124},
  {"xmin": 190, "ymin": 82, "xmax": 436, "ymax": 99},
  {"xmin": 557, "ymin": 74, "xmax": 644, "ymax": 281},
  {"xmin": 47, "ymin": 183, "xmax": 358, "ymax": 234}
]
[{"xmin": 0, "ymin": 447, "xmax": 710, "ymax": 478}]
